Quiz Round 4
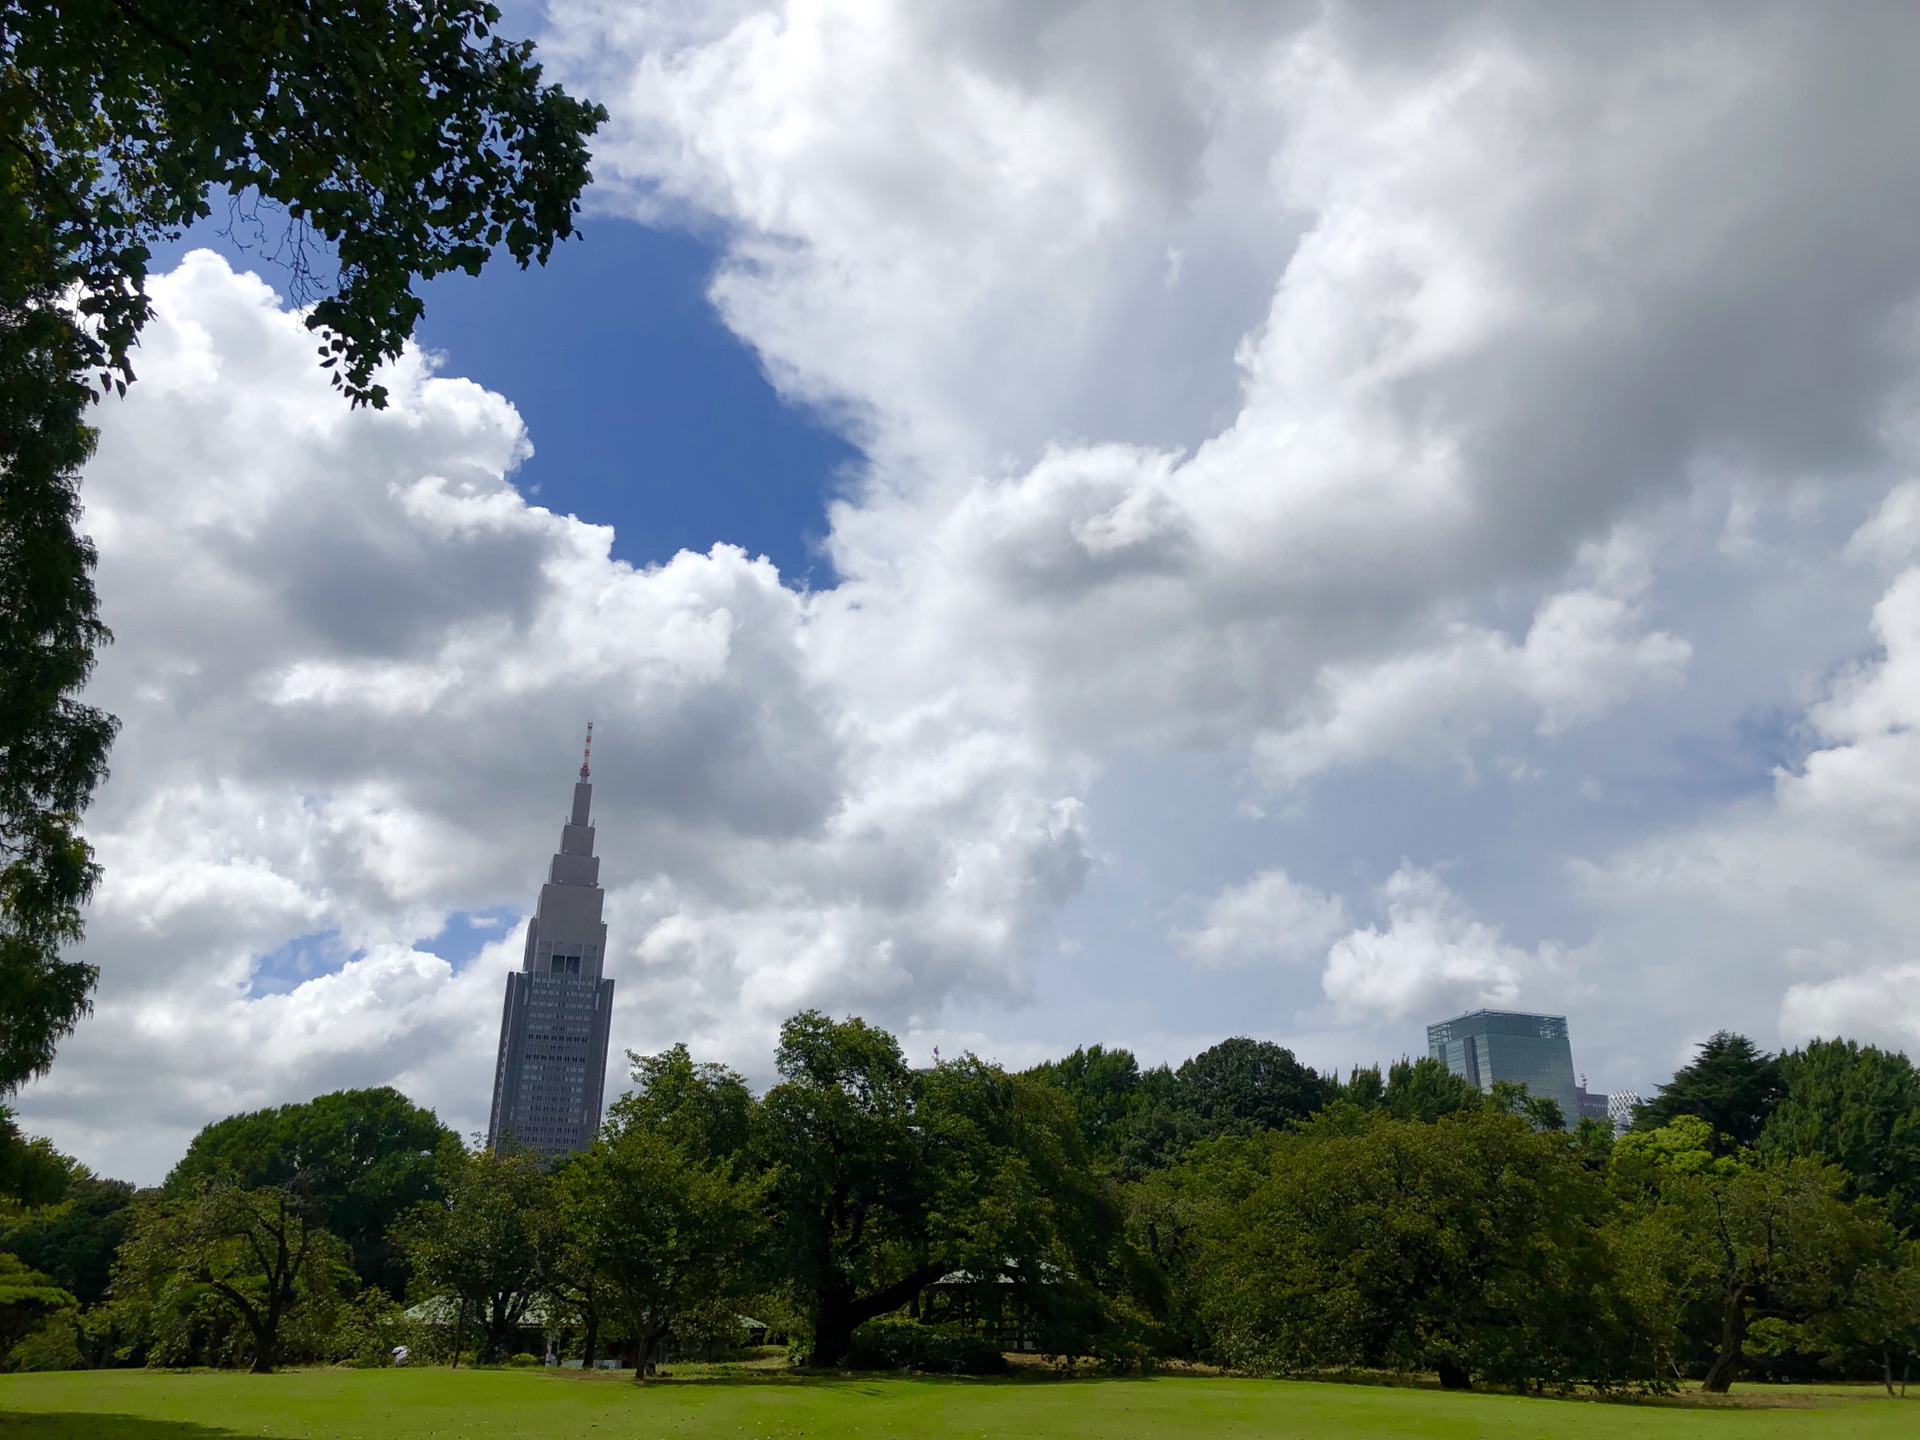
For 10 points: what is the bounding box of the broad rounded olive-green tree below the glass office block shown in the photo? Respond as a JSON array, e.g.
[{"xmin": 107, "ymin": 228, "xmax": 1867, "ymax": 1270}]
[{"xmin": 1187, "ymin": 1108, "xmax": 1620, "ymax": 1388}]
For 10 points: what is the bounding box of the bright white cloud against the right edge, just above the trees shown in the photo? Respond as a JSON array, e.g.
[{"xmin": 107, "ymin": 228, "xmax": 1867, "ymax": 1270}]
[{"xmin": 1576, "ymin": 486, "xmax": 1920, "ymax": 1046}]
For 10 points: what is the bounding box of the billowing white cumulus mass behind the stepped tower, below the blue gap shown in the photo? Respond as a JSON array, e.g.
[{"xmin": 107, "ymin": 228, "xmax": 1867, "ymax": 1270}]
[{"xmin": 25, "ymin": 252, "xmax": 1087, "ymax": 1175}]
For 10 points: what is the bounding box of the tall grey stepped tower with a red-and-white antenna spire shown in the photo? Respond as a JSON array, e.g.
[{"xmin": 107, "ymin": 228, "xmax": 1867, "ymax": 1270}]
[{"xmin": 488, "ymin": 726, "xmax": 612, "ymax": 1156}]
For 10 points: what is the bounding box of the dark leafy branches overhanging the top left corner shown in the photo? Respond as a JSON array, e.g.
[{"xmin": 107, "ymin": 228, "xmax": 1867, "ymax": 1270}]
[{"xmin": 0, "ymin": 0, "xmax": 605, "ymax": 405}]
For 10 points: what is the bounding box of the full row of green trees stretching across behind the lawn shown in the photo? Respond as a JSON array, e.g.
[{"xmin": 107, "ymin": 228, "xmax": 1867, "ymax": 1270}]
[{"xmin": 0, "ymin": 1012, "xmax": 1920, "ymax": 1390}]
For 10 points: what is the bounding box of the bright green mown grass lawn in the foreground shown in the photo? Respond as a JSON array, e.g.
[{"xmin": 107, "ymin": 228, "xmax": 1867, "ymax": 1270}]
[{"xmin": 0, "ymin": 1369, "xmax": 1920, "ymax": 1440}]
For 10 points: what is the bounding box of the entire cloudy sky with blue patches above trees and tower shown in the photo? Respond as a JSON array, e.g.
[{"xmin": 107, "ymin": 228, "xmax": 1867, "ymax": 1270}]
[{"xmin": 19, "ymin": 0, "xmax": 1920, "ymax": 1181}]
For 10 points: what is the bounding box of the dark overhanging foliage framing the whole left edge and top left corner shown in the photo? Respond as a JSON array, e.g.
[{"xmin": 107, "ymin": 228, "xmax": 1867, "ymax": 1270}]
[{"xmin": 0, "ymin": 0, "xmax": 605, "ymax": 1092}]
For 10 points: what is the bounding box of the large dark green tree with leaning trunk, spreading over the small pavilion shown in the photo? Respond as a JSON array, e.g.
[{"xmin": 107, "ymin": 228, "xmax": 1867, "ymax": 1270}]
[{"xmin": 755, "ymin": 1010, "xmax": 1133, "ymax": 1365}]
